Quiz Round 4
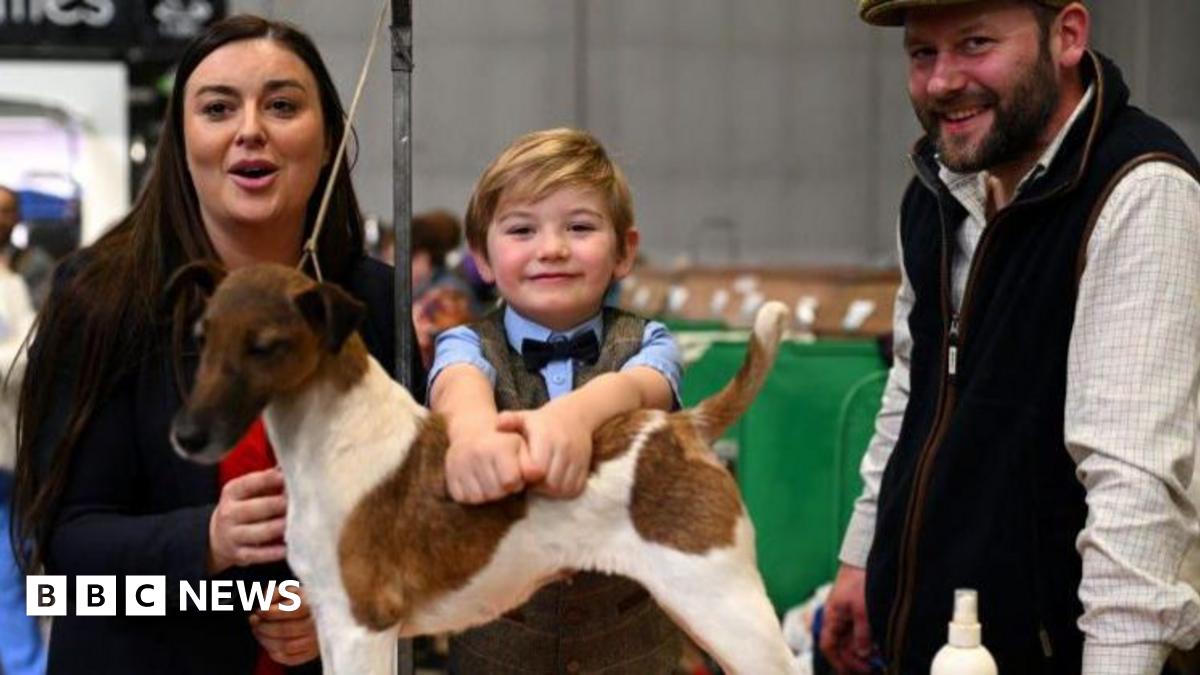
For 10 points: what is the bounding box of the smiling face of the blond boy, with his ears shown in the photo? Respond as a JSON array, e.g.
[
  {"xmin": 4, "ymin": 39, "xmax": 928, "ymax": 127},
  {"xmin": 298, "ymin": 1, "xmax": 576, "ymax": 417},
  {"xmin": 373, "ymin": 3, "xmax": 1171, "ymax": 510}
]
[{"xmin": 474, "ymin": 187, "xmax": 637, "ymax": 330}]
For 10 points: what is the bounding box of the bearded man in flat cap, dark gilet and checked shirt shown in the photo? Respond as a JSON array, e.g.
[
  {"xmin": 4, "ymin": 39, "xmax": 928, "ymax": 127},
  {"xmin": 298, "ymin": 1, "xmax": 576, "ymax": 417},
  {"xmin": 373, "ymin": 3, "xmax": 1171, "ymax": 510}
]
[{"xmin": 821, "ymin": 0, "xmax": 1200, "ymax": 675}]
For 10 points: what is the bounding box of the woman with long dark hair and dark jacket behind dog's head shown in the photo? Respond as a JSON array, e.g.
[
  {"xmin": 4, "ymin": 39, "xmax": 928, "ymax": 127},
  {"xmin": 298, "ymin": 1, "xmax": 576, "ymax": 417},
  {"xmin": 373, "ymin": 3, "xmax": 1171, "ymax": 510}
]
[{"xmin": 9, "ymin": 16, "xmax": 417, "ymax": 675}]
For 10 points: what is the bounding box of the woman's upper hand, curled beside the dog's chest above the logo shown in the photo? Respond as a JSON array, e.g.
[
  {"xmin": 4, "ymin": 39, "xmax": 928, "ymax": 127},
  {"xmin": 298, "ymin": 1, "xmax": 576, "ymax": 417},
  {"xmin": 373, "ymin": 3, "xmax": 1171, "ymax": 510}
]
[{"xmin": 205, "ymin": 468, "xmax": 288, "ymax": 574}]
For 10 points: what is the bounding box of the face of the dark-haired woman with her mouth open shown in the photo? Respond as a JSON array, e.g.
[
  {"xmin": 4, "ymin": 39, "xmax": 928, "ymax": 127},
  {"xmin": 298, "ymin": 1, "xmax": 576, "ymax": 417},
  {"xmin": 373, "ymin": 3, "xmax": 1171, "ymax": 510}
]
[{"xmin": 184, "ymin": 38, "xmax": 329, "ymax": 252}]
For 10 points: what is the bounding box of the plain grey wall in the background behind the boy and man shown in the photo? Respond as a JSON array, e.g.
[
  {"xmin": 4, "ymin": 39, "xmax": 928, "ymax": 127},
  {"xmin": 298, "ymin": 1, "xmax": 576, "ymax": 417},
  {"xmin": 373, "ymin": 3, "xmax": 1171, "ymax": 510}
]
[{"xmin": 230, "ymin": 0, "xmax": 1200, "ymax": 264}]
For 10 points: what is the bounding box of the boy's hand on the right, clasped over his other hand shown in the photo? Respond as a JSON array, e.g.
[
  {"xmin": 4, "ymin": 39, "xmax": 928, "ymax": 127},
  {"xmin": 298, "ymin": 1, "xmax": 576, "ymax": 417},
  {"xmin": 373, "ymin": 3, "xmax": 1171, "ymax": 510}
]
[{"xmin": 496, "ymin": 404, "xmax": 592, "ymax": 498}]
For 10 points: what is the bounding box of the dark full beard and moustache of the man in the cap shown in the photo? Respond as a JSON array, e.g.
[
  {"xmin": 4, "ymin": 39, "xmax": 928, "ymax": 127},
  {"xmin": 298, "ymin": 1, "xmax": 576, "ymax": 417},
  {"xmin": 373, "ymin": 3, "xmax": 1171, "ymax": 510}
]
[{"xmin": 913, "ymin": 48, "xmax": 1058, "ymax": 173}]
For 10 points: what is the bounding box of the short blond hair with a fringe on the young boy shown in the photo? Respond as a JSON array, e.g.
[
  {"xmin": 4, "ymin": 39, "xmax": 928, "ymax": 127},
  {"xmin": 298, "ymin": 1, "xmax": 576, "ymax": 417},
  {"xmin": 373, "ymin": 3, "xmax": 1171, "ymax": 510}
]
[{"xmin": 466, "ymin": 127, "xmax": 634, "ymax": 258}]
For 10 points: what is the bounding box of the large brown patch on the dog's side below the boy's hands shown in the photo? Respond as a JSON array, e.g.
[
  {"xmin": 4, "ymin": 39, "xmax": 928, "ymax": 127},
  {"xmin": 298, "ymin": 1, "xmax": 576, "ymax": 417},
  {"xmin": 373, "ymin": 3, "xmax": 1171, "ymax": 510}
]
[{"xmin": 338, "ymin": 414, "xmax": 527, "ymax": 631}]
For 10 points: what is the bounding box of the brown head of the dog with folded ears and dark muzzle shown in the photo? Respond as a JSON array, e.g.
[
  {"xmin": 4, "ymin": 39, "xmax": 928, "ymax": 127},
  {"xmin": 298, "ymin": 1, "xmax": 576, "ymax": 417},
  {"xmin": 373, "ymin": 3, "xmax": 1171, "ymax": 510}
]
[{"xmin": 167, "ymin": 263, "xmax": 364, "ymax": 464}]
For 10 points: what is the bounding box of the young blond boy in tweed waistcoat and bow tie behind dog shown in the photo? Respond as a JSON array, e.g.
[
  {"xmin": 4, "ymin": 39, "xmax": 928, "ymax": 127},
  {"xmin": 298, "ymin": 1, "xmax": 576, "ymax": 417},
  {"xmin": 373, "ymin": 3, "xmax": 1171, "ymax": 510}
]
[{"xmin": 430, "ymin": 129, "xmax": 682, "ymax": 675}]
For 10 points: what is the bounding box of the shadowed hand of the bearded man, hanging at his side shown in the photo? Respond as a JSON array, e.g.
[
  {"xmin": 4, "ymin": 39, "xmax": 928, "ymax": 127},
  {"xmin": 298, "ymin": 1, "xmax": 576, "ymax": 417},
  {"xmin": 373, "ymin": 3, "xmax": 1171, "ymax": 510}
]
[{"xmin": 821, "ymin": 565, "xmax": 872, "ymax": 675}]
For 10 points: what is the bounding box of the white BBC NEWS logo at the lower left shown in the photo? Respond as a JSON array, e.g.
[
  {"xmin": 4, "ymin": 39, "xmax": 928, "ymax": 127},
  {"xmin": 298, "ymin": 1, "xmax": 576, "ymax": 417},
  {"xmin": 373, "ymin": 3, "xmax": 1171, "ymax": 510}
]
[{"xmin": 25, "ymin": 574, "xmax": 300, "ymax": 616}]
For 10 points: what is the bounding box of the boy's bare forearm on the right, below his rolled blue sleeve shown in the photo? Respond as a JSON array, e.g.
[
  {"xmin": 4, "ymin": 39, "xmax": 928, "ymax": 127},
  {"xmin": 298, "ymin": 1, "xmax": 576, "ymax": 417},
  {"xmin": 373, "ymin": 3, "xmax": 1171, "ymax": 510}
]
[{"xmin": 546, "ymin": 368, "xmax": 673, "ymax": 429}]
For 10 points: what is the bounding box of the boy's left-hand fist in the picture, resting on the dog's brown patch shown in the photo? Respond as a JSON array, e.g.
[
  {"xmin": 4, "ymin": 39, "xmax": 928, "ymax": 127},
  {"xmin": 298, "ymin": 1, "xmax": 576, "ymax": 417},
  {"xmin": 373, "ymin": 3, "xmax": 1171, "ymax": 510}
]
[{"xmin": 446, "ymin": 431, "xmax": 527, "ymax": 504}]
